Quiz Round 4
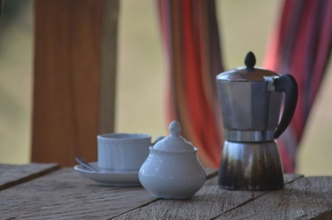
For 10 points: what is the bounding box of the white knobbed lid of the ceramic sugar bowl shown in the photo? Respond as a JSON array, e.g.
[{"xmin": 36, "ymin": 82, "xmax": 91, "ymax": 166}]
[{"xmin": 153, "ymin": 121, "xmax": 195, "ymax": 152}]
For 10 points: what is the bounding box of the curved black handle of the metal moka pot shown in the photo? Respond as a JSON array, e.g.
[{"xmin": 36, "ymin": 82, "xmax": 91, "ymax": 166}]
[{"xmin": 273, "ymin": 74, "xmax": 298, "ymax": 139}]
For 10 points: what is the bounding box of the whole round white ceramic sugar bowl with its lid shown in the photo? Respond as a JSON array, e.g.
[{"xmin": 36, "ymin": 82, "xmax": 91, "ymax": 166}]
[{"xmin": 139, "ymin": 121, "xmax": 206, "ymax": 199}]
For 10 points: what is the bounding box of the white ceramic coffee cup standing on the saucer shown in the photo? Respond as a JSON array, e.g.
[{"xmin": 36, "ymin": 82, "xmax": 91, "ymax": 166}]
[{"xmin": 97, "ymin": 133, "xmax": 152, "ymax": 172}]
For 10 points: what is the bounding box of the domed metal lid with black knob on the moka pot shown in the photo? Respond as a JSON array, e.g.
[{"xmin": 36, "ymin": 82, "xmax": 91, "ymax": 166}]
[{"xmin": 217, "ymin": 51, "xmax": 279, "ymax": 82}]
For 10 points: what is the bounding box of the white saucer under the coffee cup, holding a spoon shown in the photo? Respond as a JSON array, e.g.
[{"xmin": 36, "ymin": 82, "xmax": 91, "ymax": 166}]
[{"xmin": 74, "ymin": 162, "xmax": 141, "ymax": 186}]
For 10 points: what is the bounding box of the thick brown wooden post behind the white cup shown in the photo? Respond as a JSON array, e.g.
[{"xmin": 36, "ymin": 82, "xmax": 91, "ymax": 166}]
[{"xmin": 31, "ymin": 0, "xmax": 119, "ymax": 166}]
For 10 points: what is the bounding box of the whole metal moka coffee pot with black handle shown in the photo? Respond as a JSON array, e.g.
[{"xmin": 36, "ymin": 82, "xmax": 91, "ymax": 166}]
[{"xmin": 217, "ymin": 52, "xmax": 298, "ymax": 190}]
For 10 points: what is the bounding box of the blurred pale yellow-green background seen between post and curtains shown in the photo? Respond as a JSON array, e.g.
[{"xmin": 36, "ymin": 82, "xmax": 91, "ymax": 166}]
[{"xmin": 0, "ymin": 0, "xmax": 332, "ymax": 175}]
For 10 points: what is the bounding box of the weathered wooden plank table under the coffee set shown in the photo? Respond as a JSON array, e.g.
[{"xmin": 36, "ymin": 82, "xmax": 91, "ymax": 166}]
[{"xmin": 0, "ymin": 164, "xmax": 332, "ymax": 220}]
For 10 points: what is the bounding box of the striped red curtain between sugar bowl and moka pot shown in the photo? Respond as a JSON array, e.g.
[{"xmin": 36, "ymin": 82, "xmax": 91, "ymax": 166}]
[{"xmin": 158, "ymin": 0, "xmax": 223, "ymax": 167}]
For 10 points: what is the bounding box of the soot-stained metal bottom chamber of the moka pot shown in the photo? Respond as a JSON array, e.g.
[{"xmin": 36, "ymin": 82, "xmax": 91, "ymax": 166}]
[{"xmin": 218, "ymin": 141, "xmax": 284, "ymax": 190}]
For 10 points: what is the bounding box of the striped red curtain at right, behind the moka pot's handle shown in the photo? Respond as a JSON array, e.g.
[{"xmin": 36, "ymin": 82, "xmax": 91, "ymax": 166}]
[{"xmin": 264, "ymin": 0, "xmax": 332, "ymax": 172}]
